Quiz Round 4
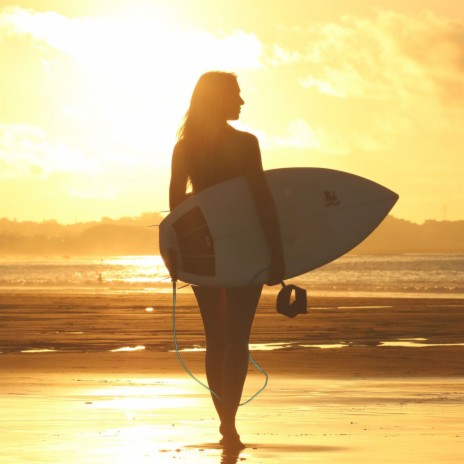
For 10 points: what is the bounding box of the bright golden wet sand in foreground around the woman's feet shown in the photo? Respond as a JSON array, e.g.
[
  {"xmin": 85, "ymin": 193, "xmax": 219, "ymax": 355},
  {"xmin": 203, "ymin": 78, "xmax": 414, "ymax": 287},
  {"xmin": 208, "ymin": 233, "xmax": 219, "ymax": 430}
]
[{"xmin": 0, "ymin": 372, "xmax": 464, "ymax": 464}]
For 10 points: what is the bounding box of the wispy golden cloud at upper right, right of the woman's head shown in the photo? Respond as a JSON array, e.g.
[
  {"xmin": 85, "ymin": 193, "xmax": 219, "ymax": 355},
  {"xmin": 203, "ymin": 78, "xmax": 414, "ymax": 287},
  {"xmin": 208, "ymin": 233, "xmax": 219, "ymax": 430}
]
[{"xmin": 270, "ymin": 12, "xmax": 464, "ymax": 103}]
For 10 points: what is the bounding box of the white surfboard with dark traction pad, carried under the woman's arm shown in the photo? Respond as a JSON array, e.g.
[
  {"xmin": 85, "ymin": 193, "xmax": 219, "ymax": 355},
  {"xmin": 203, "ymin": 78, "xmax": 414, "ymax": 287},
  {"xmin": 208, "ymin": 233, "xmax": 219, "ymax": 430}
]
[{"xmin": 159, "ymin": 168, "xmax": 398, "ymax": 287}]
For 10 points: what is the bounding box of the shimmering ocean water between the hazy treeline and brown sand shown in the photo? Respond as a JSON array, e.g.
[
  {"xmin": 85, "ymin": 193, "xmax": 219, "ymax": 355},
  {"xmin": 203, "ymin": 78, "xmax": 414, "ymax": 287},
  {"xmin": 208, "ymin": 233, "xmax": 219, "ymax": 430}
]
[{"xmin": 0, "ymin": 254, "xmax": 464, "ymax": 298}]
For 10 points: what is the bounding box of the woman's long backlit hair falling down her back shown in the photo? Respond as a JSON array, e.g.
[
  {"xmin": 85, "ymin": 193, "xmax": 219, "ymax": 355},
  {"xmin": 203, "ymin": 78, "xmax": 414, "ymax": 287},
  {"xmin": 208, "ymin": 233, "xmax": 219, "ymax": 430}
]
[{"xmin": 177, "ymin": 71, "xmax": 238, "ymax": 188}]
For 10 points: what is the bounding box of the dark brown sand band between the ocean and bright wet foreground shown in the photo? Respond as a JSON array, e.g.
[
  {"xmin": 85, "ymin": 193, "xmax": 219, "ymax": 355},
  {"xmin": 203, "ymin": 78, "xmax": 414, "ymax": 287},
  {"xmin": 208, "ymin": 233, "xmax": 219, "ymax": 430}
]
[{"xmin": 0, "ymin": 290, "xmax": 464, "ymax": 378}]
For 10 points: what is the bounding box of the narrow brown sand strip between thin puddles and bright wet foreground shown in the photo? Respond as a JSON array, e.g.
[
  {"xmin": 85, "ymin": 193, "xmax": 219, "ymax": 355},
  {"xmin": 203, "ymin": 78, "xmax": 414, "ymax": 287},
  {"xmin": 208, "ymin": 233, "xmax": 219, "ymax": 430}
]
[{"xmin": 0, "ymin": 347, "xmax": 464, "ymax": 379}]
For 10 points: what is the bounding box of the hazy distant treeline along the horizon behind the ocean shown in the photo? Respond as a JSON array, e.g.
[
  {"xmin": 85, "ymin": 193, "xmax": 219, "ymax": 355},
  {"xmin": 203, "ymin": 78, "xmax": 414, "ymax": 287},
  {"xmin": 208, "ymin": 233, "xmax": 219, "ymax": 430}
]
[{"xmin": 0, "ymin": 213, "xmax": 464, "ymax": 256}]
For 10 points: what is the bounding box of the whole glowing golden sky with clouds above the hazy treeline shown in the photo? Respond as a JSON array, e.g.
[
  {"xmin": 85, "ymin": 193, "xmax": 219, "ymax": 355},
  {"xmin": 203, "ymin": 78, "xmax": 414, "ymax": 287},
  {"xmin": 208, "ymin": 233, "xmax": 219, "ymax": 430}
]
[{"xmin": 0, "ymin": 0, "xmax": 464, "ymax": 223}]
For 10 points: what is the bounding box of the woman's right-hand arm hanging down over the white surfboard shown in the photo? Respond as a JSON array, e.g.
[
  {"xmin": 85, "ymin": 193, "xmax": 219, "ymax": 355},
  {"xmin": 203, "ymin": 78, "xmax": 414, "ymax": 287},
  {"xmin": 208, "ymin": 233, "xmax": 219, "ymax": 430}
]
[{"xmin": 247, "ymin": 136, "xmax": 285, "ymax": 285}]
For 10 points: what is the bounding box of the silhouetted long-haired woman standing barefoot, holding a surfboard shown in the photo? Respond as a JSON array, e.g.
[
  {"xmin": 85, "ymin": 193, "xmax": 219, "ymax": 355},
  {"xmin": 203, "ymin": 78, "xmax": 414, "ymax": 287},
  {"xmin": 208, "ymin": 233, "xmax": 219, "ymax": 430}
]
[{"xmin": 169, "ymin": 72, "xmax": 284, "ymax": 448}]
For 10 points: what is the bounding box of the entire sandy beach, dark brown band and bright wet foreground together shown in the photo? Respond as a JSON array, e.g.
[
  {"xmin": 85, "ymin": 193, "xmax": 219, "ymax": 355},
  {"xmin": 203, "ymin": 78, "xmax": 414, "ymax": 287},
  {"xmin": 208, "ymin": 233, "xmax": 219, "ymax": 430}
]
[{"xmin": 0, "ymin": 289, "xmax": 464, "ymax": 464}]
